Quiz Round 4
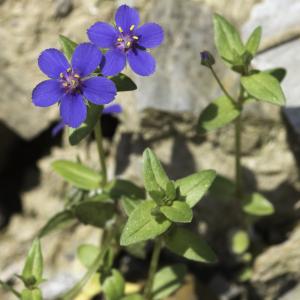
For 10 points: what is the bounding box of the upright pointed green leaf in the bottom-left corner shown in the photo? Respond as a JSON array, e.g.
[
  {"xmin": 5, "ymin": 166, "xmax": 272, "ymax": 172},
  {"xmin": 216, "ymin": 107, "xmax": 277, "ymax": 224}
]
[{"xmin": 21, "ymin": 239, "xmax": 43, "ymax": 287}]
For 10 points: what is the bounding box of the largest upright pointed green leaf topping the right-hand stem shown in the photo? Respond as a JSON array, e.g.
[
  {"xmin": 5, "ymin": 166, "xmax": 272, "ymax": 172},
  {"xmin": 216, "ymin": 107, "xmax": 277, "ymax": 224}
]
[{"xmin": 213, "ymin": 14, "xmax": 245, "ymax": 62}]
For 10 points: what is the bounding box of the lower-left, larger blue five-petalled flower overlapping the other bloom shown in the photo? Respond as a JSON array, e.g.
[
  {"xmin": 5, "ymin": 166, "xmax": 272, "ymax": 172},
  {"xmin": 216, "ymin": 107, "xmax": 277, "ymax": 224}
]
[{"xmin": 32, "ymin": 43, "xmax": 117, "ymax": 128}]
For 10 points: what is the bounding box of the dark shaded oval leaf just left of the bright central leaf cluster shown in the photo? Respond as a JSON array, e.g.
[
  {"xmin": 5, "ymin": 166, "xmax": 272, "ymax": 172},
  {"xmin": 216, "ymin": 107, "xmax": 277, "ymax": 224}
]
[{"xmin": 74, "ymin": 201, "xmax": 115, "ymax": 228}]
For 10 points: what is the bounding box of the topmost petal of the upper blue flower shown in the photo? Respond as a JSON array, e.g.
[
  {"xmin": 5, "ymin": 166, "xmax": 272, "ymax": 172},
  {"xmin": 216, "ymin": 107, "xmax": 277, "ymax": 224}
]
[{"xmin": 115, "ymin": 5, "xmax": 140, "ymax": 32}]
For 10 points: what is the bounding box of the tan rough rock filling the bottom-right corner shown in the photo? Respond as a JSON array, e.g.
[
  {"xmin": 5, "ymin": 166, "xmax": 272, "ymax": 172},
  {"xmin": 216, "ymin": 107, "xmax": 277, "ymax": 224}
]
[{"xmin": 251, "ymin": 226, "xmax": 300, "ymax": 300}]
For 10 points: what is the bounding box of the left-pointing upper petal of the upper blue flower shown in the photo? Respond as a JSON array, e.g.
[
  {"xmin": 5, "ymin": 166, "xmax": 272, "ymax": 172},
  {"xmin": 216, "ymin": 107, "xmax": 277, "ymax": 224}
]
[{"xmin": 87, "ymin": 22, "xmax": 118, "ymax": 48}]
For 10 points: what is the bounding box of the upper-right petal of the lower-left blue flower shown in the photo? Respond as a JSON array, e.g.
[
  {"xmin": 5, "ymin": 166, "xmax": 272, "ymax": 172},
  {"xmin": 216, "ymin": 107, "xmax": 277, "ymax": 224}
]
[{"xmin": 72, "ymin": 43, "xmax": 102, "ymax": 77}]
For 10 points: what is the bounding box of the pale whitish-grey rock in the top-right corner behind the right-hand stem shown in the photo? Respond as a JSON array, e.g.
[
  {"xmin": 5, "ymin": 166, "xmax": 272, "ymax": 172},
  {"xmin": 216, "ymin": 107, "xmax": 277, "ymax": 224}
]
[{"xmin": 243, "ymin": 0, "xmax": 300, "ymax": 134}]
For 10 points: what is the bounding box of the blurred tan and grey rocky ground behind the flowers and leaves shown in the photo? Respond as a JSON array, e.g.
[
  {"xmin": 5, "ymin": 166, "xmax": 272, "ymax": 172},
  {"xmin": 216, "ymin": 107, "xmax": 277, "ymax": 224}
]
[{"xmin": 0, "ymin": 0, "xmax": 300, "ymax": 300}]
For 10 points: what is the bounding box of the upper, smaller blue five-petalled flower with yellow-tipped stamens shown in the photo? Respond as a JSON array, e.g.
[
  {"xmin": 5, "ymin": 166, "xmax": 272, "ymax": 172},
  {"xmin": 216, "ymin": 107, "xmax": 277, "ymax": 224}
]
[{"xmin": 87, "ymin": 5, "xmax": 164, "ymax": 76}]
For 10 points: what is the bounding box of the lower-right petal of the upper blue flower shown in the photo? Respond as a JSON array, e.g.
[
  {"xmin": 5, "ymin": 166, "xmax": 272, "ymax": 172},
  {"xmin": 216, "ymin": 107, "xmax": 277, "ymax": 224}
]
[{"xmin": 127, "ymin": 49, "xmax": 155, "ymax": 76}]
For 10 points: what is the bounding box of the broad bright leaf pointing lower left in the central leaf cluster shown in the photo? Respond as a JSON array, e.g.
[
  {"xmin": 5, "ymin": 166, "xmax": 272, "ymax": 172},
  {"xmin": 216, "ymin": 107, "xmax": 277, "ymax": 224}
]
[{"xmin": 121, "ymin": 200, "xmax": 171, "ymax": 246}]
